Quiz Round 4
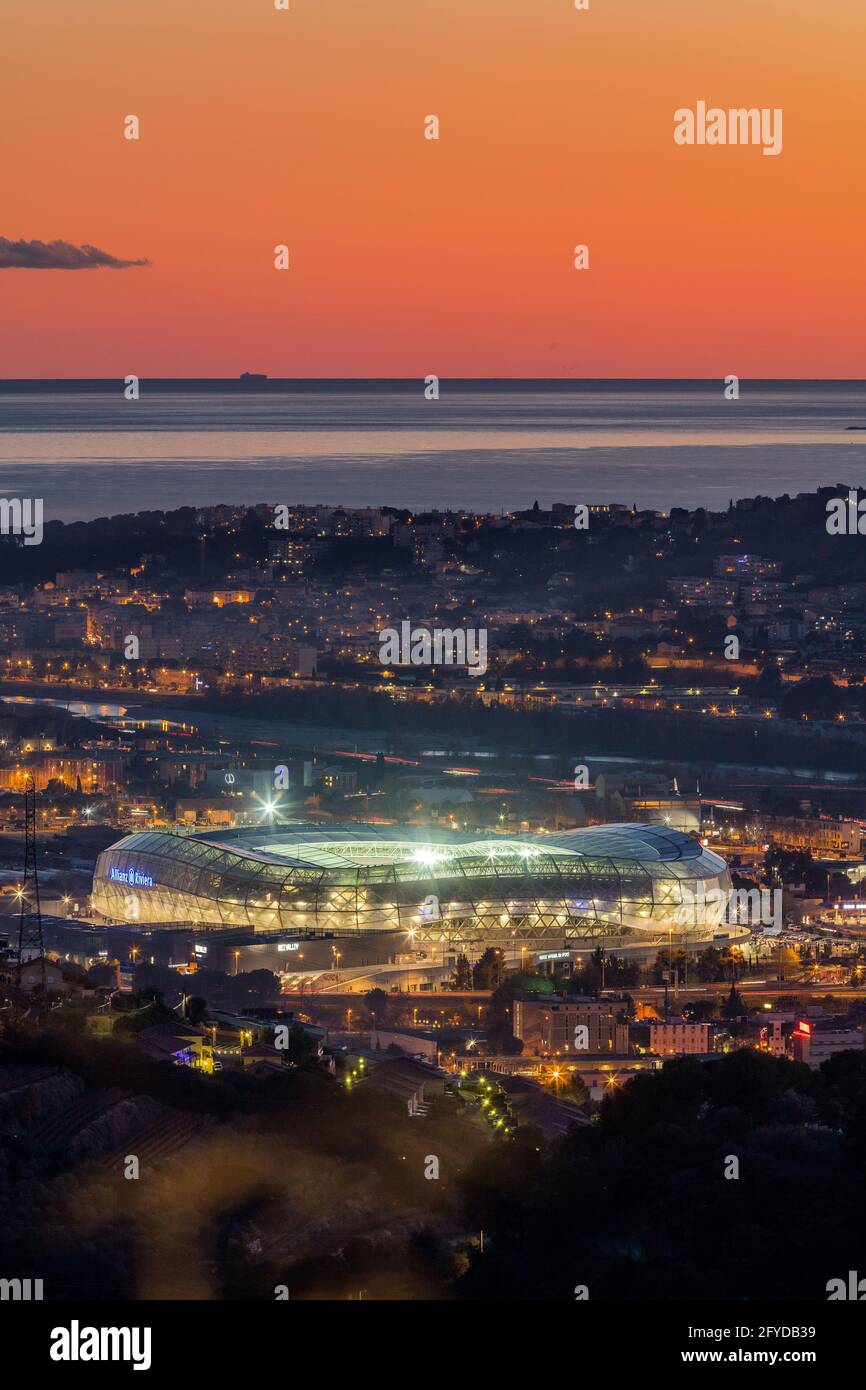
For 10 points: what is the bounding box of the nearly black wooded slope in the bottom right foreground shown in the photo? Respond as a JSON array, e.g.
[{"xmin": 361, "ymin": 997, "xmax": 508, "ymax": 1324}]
[{"xmin": 455, "ymin": 1049, "xmax": 866, "ymax": 1300}]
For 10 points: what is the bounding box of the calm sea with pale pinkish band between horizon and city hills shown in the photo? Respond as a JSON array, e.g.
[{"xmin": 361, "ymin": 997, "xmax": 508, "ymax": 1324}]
[{"xmin": 0, "ymin": 381, "xmax": 866, "ymax": 520}]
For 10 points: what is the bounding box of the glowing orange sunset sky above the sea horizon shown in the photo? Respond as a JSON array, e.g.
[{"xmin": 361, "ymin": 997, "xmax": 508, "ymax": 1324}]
[{"xmin": 0, "ymin": 0, "xmax": 866, "ymax": 377}]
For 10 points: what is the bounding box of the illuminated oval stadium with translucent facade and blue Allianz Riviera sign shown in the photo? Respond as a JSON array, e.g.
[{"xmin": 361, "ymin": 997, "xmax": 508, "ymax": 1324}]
[{"xmin": 93, "ymin": 824, "xmax": 730, "ymax": 944}]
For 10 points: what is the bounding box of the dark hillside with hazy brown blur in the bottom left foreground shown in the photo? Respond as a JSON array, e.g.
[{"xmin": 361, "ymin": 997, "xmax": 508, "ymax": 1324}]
[{"xmin": 0, "ymin": 1022, "xmax": 488, "ymax": 1300}]
